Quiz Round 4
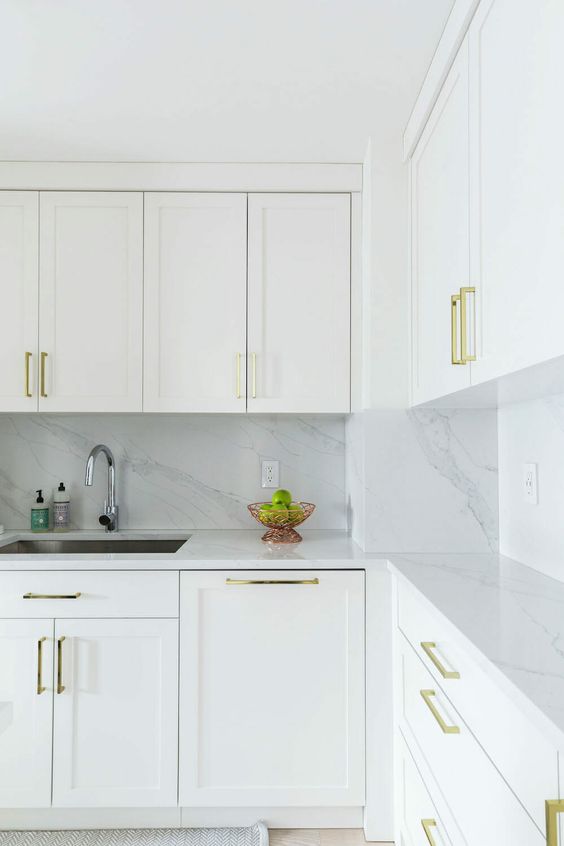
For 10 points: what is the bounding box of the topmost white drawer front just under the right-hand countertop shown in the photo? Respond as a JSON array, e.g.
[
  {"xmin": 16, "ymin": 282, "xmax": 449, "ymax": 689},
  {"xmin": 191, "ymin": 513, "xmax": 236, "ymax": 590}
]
[{"xmin": 398, "ymin": 583, "xmax": 558, "ymax": 828}]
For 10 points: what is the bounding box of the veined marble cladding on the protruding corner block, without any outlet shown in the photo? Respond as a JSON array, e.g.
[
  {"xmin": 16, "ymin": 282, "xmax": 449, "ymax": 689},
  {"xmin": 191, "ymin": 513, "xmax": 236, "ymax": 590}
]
[{"xmin": 347, "ymin": 409, "xmax": 498, "ymax": 553}]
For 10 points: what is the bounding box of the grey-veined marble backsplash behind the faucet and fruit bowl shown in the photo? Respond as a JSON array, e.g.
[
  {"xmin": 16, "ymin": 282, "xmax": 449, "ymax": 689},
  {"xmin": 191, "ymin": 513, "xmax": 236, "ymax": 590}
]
[{"xmin": 0, "ymin": 414, "xmax": 347, "ymax": 531}]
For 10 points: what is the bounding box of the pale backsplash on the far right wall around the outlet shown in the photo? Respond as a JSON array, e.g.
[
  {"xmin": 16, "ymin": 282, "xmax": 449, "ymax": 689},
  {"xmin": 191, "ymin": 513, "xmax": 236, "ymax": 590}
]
[{"xmin": 499, "ymin": 394, "xmax": 564, "ymax": 581}]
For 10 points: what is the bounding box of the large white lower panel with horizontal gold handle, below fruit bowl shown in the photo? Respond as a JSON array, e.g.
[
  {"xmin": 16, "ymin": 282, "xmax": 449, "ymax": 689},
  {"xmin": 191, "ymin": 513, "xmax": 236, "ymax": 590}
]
[{"xmin": 179, "ymin": 571, "xmax": 364, "ymax": 807}]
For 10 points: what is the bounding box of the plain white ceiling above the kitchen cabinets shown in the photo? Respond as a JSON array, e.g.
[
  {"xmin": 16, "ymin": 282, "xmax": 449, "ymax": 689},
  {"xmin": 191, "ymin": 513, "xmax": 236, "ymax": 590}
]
[{"xmin": 0, "ymin": 0, "xmax": 453, "ymax": 161}]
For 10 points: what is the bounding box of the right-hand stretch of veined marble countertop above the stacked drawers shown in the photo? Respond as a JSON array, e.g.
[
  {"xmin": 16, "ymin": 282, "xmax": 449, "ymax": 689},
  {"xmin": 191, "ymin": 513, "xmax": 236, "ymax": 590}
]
[{"xmin": 388, "ymin": 554, "xmax": 564, "ymax": 750}]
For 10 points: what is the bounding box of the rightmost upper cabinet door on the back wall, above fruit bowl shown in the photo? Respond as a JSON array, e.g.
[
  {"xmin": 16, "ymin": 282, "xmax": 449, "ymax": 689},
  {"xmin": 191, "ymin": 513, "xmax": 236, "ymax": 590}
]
[{"xmin": 247, "ymin": 194, "xmax": 350, "ymax": 412}]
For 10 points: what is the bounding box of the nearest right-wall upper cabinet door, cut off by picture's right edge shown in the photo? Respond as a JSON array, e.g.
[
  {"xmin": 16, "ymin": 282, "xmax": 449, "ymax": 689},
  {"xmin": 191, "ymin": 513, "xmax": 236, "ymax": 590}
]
[{"xmin": 470, "ymin": 0, "xmax": 564, "ymax": 382}]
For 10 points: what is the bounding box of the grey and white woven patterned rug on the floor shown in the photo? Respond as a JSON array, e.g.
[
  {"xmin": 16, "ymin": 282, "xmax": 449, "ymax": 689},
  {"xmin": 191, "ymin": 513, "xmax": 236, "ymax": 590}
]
[{"xmin": 0, "ymin": 823, "xmax": 268, "ymax": 846}]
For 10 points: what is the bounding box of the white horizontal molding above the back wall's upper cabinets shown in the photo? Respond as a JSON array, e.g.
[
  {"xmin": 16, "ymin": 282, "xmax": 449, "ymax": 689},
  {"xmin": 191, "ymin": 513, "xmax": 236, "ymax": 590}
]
[{"xmin": 0, "ymin": 162, "xmax": 362, "ymax": 193}]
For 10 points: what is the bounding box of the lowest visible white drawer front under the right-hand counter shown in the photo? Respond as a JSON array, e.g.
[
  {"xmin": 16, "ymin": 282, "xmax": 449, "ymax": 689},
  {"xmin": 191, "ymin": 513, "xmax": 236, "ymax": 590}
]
[{"xmin": 396, "ymin": 732, "xmax": 461, "ymax": 846}]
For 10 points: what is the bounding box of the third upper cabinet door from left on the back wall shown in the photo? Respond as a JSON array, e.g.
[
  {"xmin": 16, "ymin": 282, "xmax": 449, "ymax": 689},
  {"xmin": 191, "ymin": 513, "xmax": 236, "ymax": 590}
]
[{"xmin": 143, "ymin": 193, "xmax": 247, "ymax": 412}]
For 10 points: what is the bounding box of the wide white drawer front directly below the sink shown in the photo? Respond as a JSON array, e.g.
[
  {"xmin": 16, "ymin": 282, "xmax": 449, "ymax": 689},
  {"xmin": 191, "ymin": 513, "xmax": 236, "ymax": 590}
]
[{"xmin": 0, "ymin": 570, "xmax": 178, "ymax": 619}]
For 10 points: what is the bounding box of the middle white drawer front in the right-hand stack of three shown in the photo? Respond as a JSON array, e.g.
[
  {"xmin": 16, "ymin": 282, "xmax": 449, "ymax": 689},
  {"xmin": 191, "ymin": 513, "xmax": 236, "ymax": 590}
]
[{"xmin": 397, "ymin": 632, "xmax": 544, "ymax": 846}]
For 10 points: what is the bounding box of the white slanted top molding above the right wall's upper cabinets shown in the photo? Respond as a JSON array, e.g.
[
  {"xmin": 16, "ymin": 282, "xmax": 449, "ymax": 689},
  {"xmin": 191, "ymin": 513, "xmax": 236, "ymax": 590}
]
[{"xmin": 403, "ymin": 0, "xmax": 481, "ymax": 161}]
